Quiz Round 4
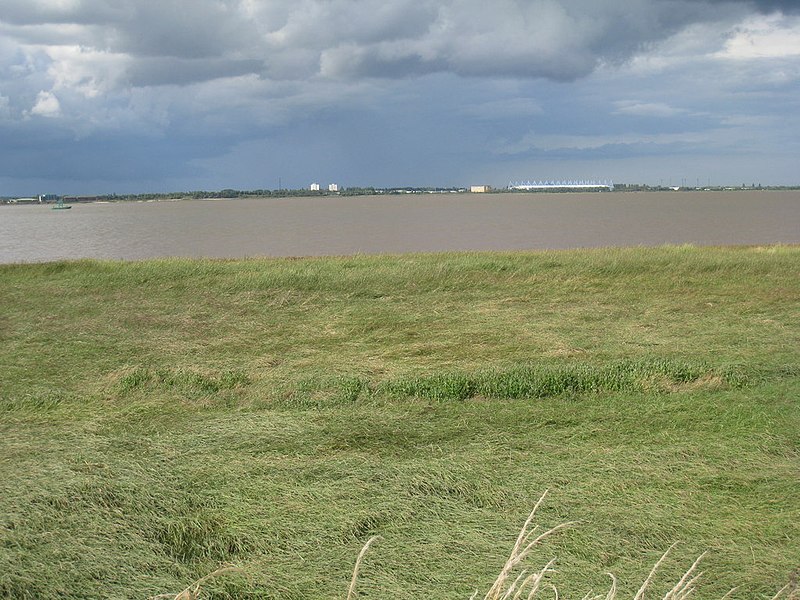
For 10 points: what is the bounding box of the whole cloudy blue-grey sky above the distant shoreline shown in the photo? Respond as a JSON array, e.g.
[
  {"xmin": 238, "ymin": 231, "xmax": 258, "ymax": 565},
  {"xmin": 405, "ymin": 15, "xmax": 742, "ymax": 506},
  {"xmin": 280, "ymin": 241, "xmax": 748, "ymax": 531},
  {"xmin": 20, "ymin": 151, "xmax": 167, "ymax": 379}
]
[{"xmin": 0, "ymin": 0, "xmax": 800, "ymax": 196}]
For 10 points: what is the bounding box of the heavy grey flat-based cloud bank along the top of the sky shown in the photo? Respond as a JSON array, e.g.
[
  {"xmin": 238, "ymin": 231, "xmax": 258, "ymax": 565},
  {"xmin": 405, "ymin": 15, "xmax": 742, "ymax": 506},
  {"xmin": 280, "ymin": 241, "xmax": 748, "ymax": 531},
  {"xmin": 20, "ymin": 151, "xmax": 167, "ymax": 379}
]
[{"xmin": 0, "ymin": 0, "xmax": 798, "ymax": 85}]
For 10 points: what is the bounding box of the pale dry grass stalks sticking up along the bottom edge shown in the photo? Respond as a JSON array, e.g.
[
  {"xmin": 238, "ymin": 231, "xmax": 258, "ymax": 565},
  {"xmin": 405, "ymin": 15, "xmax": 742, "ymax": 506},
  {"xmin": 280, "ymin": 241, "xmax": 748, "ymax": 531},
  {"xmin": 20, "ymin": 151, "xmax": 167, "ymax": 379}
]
[{"xmin": 148, "ymin": 491, "xmax": 800, "ymax": 600}]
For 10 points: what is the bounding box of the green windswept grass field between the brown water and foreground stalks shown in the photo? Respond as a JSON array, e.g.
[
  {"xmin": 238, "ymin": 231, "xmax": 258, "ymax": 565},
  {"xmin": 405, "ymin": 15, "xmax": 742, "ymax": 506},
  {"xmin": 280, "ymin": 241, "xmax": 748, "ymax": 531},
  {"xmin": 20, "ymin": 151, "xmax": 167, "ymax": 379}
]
[{"xmin": 0, "ymin": 247, "xmax": 800, "ymax": 600}]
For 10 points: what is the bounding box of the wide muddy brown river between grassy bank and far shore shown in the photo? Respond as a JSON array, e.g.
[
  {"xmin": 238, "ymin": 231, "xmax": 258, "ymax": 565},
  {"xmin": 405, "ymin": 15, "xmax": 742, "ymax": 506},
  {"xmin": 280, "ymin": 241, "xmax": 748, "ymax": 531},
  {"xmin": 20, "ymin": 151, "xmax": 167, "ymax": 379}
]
[{"xmin": 0, "ymin": 191, "xmax": 800, "ymax": 263}]
